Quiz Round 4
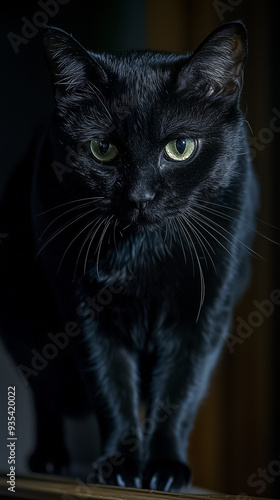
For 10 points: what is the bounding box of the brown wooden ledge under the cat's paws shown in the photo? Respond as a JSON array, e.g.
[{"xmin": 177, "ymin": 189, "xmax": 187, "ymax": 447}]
[{"xmin": 0, "ymin": 475, "xmax": 274, "ymax": 500}]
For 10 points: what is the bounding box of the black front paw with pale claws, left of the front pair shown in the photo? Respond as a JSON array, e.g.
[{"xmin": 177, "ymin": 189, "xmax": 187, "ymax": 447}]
[{"xmin": 92, "ymin": 454, "xmax": 142, "ymax": 488}]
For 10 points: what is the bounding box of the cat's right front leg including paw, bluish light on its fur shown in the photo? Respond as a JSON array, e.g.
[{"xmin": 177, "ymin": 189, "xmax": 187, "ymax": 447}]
[{"xmin": 143, "ymin": 336, "xmax": 220, "ymax": 491}]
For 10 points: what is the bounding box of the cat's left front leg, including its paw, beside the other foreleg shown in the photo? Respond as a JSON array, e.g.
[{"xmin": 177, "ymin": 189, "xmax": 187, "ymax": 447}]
[{"xmin": 79, "ymin": 340, "xmax": 142, "ymax": 488}]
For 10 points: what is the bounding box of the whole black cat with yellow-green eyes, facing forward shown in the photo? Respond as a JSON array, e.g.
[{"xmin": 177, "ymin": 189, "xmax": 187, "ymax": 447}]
[{"xmin": 0, "ymin": 22, "xmax": 258, "ymax": 491}]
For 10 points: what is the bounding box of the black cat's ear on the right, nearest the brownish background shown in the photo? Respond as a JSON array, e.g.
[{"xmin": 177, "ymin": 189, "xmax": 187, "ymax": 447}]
[{"xmin": 179, "ymin": 21, "xmax": 247, "ymax": 96}]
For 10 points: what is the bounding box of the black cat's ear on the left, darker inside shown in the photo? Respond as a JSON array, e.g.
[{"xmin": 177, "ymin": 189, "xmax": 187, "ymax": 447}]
[{"xmin": 42, "ymin": 27, "xmax": 107, "ymax": 94}]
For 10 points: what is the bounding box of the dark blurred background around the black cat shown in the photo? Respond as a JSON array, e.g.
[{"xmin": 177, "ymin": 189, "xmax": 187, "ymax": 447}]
[{"xmin": 0, "ymin": 0, "xmax": 280, "ymax": 498}]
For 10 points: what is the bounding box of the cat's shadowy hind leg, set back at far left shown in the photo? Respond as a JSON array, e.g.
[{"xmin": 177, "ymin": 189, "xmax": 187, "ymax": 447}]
[{"xmin": 29, "ymin": 399, "xmax": 69, "ymax": 474}]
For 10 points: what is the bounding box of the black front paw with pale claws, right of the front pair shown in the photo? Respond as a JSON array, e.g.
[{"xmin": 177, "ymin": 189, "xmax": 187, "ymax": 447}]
[{"xmin": 143, "ymin": 459, "xmax": 191, "ymax": 492}]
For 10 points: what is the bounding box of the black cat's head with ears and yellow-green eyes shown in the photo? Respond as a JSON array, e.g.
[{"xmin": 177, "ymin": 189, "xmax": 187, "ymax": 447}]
[{"xmin": 41, "ymin": 22, "xmax": 247, "ymax": 231}]
